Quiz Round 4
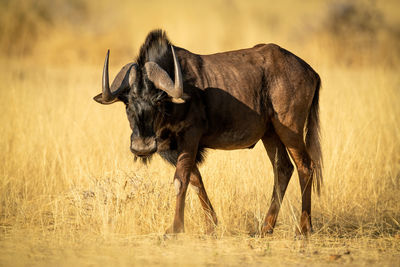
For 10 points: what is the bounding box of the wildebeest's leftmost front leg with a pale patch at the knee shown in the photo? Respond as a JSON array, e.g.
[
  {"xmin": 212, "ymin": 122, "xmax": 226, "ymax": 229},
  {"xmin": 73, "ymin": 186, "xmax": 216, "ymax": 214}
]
[{"xmin": 167, "ymin": 134, "xmax": 199, "ymax": 233}]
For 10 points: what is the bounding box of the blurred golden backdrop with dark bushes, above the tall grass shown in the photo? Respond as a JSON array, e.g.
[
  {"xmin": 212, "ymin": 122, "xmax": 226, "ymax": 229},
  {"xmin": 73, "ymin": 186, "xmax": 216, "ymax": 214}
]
[{"xmin": 0, "ymin": 0, "xmax": 400, "ymax": 66}]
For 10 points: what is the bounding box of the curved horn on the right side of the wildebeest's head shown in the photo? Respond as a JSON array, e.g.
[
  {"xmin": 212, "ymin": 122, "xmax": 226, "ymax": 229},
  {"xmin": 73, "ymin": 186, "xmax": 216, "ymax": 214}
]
[{"xmin": 144, "ymin": 45, "xmax": 185, "ymax": 103}]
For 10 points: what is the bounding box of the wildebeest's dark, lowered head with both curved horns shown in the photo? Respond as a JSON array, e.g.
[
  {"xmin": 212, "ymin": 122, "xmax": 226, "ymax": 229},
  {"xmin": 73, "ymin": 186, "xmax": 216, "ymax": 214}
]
[{"xmin": 94, "ymin": 32, "xmax": 185, "ymax": 163}]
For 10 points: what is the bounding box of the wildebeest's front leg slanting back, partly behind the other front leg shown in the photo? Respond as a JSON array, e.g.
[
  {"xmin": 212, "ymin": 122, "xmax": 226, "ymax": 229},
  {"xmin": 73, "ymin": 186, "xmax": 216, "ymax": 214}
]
[{"xmin": 190, "ymin": 166, "xmax": 218, "ymax": 234}]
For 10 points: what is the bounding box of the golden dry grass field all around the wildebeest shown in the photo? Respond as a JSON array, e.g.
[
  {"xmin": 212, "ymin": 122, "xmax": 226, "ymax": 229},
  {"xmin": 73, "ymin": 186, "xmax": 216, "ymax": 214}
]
[{"xmin": 0, "ymin": 0, "xmax": 400, "ymax": 266}]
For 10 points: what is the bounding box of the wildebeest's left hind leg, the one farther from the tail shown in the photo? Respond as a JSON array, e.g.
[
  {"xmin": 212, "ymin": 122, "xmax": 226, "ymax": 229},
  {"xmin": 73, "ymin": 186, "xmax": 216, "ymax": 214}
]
[{"xmin": 261, "ymin": 131, "xmax": 293, "ymax": 236}]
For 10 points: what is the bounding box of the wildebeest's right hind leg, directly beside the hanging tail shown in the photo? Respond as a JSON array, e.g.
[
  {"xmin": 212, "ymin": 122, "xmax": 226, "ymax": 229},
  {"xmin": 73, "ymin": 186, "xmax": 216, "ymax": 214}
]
[{"xmin": 273, "ymin": 121, "xmax": 313, "ymax": 235}]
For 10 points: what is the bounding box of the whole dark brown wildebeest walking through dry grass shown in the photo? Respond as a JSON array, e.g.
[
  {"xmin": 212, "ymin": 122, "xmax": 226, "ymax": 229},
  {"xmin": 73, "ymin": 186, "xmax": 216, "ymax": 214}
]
[{"xmin": 94, "ymin": 30, "xmax": 322, "ymax": 235}]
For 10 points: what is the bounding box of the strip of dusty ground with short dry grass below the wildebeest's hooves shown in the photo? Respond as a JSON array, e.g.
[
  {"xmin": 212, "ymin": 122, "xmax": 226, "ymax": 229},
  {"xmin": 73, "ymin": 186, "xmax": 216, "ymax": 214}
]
[{"xmin": 0, "ymin": 233, "xmax": 400, "ymax": 266}]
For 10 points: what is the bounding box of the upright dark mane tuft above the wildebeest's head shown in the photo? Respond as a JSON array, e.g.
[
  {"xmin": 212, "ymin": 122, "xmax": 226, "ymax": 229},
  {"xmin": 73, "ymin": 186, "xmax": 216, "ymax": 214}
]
[{"xmin": 136, "ymin": 29, "xmax": 171, "ymax": 67}]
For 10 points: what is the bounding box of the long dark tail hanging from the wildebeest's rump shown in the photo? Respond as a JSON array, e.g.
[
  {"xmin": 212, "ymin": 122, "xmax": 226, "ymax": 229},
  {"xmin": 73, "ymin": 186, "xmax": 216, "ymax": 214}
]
[{"xmin": 305, "ymin": 74, "xmax": 323, "ymax": 195}]
